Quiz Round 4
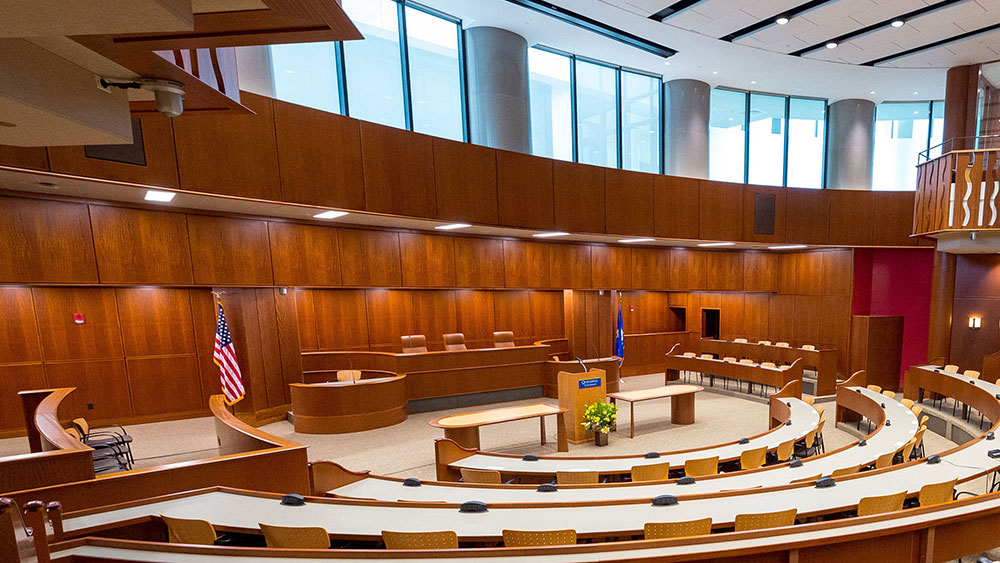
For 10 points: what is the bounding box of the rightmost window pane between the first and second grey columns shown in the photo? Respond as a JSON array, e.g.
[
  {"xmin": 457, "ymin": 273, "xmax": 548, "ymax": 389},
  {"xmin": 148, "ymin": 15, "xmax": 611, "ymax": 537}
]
[{"xmin": 622, "ymin": 71, "xmax": 662, "ymax": 173}]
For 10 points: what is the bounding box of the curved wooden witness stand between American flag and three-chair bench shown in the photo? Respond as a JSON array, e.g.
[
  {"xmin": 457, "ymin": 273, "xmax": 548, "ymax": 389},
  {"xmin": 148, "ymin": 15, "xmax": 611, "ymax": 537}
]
[{"xmin": 290, "ymin": 371, "xmax": 407, "ymax": 434}]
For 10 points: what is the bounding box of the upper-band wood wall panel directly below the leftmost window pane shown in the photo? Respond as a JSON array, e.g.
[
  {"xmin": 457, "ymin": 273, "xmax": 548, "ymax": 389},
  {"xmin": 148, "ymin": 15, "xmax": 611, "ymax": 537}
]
[{"xmin": 273, "ymin": 100, "xmax": 365, "ymax": 210}]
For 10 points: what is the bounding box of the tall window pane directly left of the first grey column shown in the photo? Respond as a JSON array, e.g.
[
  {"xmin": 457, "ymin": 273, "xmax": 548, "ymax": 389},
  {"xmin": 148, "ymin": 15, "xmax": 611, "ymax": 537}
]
[{"xmin": 406, "ymin": 6, "xmax": 465, "ymax": 141}]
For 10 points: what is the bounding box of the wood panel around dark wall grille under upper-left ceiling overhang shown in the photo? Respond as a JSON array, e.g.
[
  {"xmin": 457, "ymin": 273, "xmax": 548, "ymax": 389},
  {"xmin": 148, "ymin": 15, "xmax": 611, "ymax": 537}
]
[{"xmin": 48, "ymin": 113, "xmax": 180, "ymax": 188}]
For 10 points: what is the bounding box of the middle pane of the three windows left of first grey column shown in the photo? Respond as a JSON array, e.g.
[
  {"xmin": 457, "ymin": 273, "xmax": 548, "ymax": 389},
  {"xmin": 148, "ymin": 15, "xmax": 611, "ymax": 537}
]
[{"xmin": 343, "ymin": 0, "xmax": 406, "ymax": 128}]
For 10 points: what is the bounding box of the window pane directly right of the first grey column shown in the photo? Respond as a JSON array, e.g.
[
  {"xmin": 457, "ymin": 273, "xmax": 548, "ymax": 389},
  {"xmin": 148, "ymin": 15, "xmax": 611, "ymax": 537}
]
[{"xmin": 528, "ymin": 48, "xmax": 573, "ymax": 160}]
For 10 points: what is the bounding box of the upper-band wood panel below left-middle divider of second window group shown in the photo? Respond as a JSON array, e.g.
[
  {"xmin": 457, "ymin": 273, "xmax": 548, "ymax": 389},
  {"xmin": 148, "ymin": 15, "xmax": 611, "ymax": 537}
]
[{"xmin": 552, "ymin": 160, "xmax": 605, "ymax": 233}]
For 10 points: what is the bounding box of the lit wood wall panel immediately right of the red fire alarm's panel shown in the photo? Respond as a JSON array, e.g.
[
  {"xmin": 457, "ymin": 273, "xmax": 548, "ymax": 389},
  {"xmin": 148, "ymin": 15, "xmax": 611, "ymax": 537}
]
[{"xmin": 113, "ymin": 288, "xmax": 196, "ymax": 356}]
